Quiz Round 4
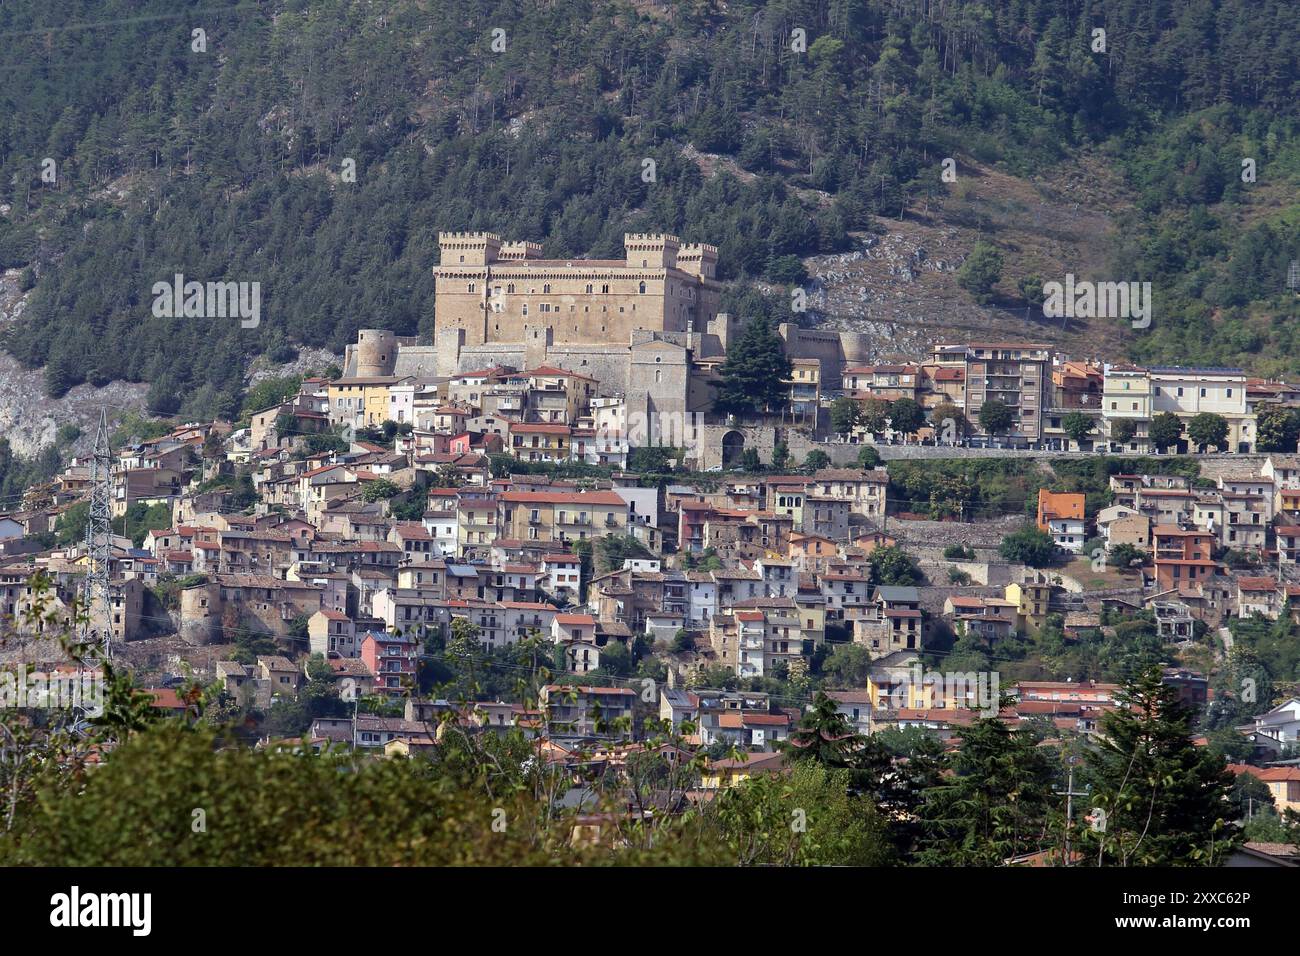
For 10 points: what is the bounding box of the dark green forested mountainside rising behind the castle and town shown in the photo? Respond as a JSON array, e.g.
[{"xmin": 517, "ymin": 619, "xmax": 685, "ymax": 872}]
[{"xmin": 0, "ymin": 0, "xmax": 1300, "ymax": 416}]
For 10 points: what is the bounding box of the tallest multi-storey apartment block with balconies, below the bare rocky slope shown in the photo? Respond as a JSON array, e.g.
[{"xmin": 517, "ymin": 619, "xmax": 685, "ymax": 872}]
[{"xmin": 966, "ymin": 342, "xmax": 1052, "ymax": 445}]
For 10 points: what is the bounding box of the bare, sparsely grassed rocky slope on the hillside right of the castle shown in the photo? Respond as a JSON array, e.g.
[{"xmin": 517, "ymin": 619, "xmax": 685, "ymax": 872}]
[{"xmin": 803, "ymin": 157, "xmax": 1130, "ymax": 362}]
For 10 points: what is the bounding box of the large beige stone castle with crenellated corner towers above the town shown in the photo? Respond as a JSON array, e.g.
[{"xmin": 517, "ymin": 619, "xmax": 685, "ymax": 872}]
[{"xmin": 345, "ymin": 233, "xmax": 865, "ymax": 444}]
